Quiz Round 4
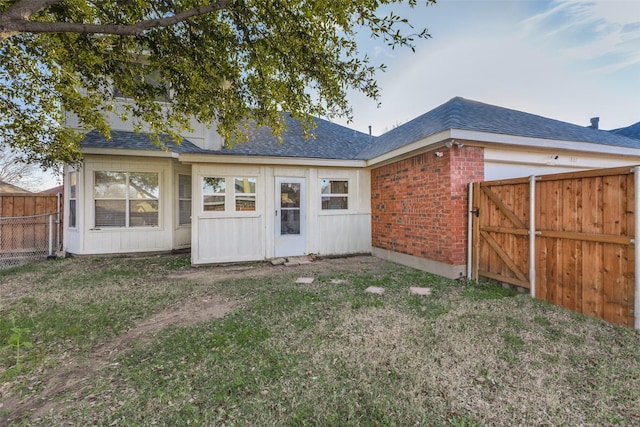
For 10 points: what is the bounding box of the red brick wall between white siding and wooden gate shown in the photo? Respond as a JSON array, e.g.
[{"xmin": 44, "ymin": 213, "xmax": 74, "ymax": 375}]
[{"xmin": 371, "ymin": 146, "xmax": 484, "ymax": 265}]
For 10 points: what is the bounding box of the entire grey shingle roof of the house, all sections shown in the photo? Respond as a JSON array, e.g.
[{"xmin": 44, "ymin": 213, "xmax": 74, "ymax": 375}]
[{"xmin": 83, "ymin": 97, "xmax": 640, "ymax": 160}]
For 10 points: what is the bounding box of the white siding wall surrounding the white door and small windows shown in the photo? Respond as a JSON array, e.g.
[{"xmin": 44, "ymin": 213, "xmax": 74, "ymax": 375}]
[{"xmin": 191, "ymin": 164, "xmax": 371, "ymax": 264}]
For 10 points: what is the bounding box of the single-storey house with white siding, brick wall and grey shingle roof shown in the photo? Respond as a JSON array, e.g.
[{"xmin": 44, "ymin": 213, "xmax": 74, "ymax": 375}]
[{"xmin": 64, "ymin": 97, "xmax": 640, "ymax": 278}]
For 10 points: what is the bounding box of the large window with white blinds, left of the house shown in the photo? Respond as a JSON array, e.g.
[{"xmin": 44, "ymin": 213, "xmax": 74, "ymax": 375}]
[{"xmin": 94, "ymin": 172, "xmax": 159, "ymax": 227}]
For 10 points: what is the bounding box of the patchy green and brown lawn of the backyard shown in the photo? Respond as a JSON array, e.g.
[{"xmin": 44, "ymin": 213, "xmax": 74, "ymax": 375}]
[{"xmin": 0, "ymin": 256, "xmax": 640, "ymax": 426}]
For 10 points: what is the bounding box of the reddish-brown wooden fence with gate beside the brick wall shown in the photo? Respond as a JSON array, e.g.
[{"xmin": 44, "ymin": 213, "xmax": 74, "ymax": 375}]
[{"xmin": 471, "ymin": 167, "xmax": 640, "ymax": 328}]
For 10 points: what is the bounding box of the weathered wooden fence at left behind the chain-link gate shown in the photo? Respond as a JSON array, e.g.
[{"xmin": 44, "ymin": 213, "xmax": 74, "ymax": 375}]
[{"xmin": 0, "ymin": 193, "xmax": 62, "ymax": 254}]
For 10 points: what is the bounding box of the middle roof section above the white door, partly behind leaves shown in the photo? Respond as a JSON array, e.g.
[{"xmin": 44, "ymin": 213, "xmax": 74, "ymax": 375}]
[{"xmin": 215, "ymin": 115, "xmax": 374, "ymax": 160}]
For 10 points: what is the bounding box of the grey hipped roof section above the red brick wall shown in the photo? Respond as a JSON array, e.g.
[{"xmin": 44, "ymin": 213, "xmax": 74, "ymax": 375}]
[{"xmin": 358, "ymin": 97, "xmax": 640, "ymax": 159}]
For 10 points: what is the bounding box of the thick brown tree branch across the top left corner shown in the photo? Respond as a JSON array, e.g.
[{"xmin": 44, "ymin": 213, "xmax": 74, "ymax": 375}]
[{"xmin": 0, "ymin": 0, "xmax": 230, "ymax": 42}]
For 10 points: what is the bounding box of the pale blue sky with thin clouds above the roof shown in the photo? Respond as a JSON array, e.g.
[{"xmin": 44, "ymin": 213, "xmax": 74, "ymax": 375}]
[{"xmin": 334, "ymin": 0, "xmax": 640, "ymax": 135}]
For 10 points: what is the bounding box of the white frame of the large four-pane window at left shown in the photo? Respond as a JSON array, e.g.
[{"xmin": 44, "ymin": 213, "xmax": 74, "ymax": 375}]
[{"xmin": 93, "ymin": 170, "xmax": 162, "ymax": 230}]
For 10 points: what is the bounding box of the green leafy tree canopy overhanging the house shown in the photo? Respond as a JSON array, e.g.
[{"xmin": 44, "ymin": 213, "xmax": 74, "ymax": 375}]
[{"xmin": 0, "ymin": 0, "xmax": 435, "ymax": 171}]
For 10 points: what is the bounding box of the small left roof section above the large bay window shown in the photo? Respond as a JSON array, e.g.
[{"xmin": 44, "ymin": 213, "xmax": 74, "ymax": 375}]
[{"xmin": 82, "ymin": 130, "xmax": 202, "ymax": 154}]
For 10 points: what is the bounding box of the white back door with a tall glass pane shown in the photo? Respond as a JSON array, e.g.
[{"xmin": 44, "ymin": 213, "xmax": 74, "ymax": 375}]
[{"xmin": 275, "ymin": 177, "xmax": 307, "ymax": 257}]
